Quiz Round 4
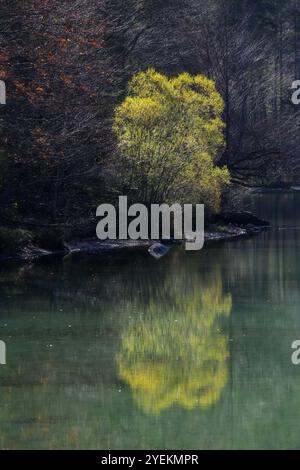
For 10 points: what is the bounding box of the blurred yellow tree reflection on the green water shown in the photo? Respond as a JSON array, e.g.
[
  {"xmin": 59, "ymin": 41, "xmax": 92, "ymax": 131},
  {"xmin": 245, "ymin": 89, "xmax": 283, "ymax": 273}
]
[{"xmin": 117, "ymin": 272, "xmax": 232, "ymax": 414}]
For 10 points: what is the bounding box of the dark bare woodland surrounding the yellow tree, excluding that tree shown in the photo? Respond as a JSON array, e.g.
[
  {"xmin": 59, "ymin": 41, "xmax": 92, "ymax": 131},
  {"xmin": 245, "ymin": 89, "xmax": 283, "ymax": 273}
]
[{"xmin": 0, "ymin": 0, "xmax": 300, "ymax": 242}]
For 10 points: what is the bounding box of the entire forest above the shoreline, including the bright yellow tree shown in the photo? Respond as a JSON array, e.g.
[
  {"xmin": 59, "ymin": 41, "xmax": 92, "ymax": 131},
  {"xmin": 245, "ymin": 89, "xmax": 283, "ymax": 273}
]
[{"xmin": 0, "ymin": 0, "xmax": 300, "ymax": 250}]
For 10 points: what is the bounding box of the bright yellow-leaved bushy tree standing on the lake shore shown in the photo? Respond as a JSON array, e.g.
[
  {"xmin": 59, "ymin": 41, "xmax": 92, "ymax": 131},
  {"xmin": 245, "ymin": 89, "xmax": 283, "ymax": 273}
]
[{"xmin": 114, "ymin": 69, "xmax": 229, "ymax": 210}]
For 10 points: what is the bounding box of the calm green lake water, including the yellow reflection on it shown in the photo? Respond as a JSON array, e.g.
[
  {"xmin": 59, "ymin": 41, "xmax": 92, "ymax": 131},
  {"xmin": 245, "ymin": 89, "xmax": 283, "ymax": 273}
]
[{"xmin": 0, "ymin": 194, "xmax": 300, "ymax": 449}]
